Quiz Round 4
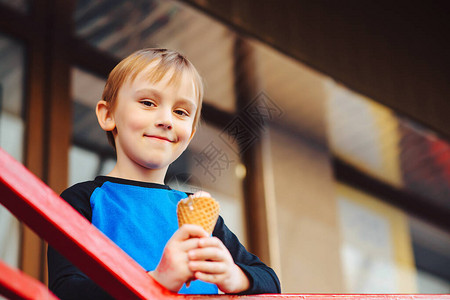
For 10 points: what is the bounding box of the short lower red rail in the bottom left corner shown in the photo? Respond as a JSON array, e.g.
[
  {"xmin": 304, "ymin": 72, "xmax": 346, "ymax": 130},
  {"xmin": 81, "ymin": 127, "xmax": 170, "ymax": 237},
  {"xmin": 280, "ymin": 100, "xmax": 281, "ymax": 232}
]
[{"xmin": 0, "ymin": 260, "xmax": 58, "ymax": 300}]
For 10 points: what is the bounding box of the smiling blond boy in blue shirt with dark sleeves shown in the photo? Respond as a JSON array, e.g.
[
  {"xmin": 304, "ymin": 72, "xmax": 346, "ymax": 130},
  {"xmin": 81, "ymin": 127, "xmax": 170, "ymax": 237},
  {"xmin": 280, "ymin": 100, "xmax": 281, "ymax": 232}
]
[{"xmin": 48, "ymin": 49, "xmax": 280, "ymax": 299}]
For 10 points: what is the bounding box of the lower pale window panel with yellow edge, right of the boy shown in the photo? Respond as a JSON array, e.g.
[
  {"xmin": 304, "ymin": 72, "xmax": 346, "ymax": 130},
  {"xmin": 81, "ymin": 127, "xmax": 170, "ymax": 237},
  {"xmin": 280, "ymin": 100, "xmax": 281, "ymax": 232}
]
[{"xmin": 336, "ymin": 184, "xmax": 416, "ymax": 293}]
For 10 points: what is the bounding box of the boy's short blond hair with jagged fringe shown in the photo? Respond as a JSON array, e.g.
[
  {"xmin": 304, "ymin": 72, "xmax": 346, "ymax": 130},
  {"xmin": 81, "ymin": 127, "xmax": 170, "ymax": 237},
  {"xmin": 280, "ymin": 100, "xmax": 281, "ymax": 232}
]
[{"xmin": 102, "ymin": 48, "xmax": 203, "ymax": 148}]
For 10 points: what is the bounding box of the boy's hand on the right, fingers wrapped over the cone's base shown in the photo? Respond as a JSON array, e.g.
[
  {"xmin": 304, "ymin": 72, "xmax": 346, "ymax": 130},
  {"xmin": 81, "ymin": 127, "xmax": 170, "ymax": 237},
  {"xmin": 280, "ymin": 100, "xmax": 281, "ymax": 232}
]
[{"xmin": 188, "ymin": 237, "xmax": 250, "ymax": 293}]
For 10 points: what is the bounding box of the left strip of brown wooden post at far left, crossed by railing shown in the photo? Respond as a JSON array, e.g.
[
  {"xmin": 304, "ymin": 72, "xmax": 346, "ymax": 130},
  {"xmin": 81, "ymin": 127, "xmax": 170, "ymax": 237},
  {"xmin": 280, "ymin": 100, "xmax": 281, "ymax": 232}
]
[{"xmin": 20, "ymin": 0, "xmax": 48, "ymax": 282}]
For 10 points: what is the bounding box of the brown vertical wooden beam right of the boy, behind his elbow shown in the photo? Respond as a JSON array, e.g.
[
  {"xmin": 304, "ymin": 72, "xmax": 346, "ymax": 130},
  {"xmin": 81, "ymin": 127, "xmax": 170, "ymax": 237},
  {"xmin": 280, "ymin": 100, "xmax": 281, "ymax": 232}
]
[{"xmin": 232, "ymin": 37, "xmax": 271, "ymax": 265}]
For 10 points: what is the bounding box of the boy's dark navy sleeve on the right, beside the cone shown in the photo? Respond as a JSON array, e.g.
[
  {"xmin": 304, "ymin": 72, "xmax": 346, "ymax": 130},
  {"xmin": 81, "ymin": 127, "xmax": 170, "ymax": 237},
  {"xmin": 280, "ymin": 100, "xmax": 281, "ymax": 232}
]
[{"xmin": 213, "ymin": 216, "xmax": 281, "ymax": 294}]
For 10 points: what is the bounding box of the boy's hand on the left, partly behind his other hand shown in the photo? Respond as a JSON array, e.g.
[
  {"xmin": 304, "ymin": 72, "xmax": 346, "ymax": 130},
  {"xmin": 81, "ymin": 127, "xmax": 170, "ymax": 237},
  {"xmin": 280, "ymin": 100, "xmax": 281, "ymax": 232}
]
[{"xmin": 149, "ymin": 224, "xmax": 208, "ymax": 292}]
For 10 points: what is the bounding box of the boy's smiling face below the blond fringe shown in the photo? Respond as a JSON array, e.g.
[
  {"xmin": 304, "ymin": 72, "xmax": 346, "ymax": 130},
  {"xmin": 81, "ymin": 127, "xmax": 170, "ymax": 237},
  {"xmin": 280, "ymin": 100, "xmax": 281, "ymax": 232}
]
[{"xmin": 111, "ymin": 64, "xmax": 198, "ymax": 173}]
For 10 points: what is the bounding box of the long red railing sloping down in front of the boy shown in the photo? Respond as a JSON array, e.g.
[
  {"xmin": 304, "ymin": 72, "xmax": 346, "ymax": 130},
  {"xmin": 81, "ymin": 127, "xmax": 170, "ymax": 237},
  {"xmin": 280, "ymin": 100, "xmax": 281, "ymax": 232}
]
[{"xmin": 0, "ymin": 148, "xmax": 450, "ymax": 300}]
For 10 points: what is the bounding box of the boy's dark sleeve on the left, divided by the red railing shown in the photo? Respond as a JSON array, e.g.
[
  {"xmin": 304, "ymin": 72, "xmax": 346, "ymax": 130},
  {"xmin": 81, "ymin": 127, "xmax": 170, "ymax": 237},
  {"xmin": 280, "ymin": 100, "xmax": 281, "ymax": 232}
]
[{"xmin": 47, "ymin": 182, "xmax": 114, "ymax": 299}]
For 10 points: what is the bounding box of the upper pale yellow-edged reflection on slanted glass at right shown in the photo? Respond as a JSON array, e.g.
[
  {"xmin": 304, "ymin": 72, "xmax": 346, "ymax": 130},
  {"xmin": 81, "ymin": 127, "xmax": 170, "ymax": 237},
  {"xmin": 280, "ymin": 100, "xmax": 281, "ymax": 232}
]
[{"xmin": 328, "ymin": 85, "xmax": 403, "ymax": 187}]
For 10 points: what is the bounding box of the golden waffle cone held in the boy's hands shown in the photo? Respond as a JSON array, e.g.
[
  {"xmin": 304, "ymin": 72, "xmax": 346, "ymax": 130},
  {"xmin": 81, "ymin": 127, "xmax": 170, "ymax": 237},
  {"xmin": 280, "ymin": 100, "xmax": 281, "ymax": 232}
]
[{"xmin": 177, "ymin": 196, "xmax": 220, "ymax": 234}]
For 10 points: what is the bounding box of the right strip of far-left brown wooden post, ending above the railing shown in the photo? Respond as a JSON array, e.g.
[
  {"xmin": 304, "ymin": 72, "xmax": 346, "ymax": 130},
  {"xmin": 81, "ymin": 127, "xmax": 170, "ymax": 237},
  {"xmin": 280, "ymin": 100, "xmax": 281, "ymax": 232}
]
[{"xmin": 44, "ymin": 0, "xmax": 75, "ymax": 193}]
